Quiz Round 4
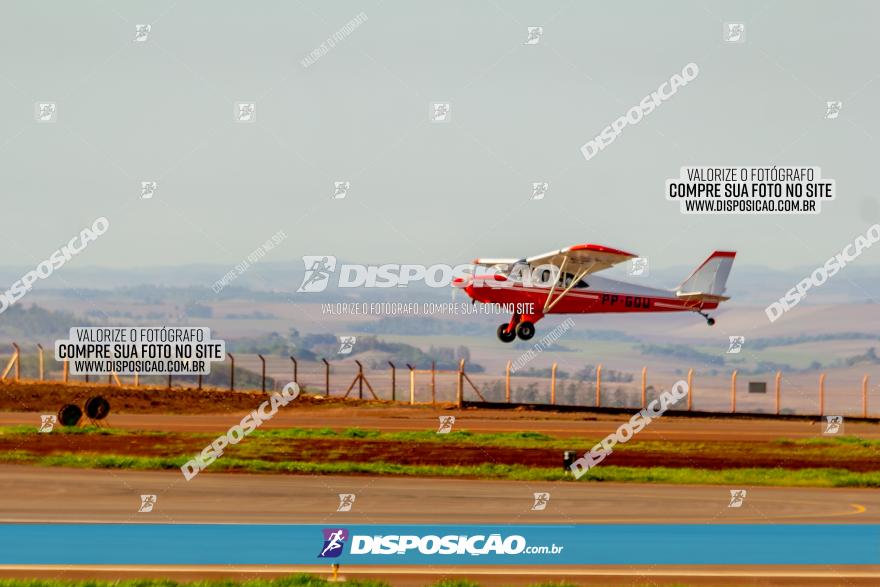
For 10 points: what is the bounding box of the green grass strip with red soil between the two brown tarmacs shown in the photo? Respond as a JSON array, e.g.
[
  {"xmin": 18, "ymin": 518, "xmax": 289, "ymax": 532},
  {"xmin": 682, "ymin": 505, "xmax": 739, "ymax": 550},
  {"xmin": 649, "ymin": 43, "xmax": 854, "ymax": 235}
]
[{"xmin": 0, "ymin": 427, "xmax": 880, "ymax": 487}]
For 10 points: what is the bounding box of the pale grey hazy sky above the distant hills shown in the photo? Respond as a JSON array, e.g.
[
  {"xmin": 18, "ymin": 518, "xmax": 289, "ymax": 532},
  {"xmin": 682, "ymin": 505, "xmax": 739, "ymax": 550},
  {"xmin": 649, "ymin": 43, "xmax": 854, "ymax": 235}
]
[{"xmin": 0, "ymin": 0, "xmax": 880, "ymax": 274}]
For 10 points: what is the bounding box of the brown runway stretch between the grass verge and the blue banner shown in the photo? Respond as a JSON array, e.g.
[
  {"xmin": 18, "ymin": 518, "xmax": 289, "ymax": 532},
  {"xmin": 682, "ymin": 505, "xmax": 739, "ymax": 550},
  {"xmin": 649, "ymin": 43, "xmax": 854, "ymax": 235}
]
[{"xmin": 0, "ymin": 465, "xmax": 880, "ymax": 524}]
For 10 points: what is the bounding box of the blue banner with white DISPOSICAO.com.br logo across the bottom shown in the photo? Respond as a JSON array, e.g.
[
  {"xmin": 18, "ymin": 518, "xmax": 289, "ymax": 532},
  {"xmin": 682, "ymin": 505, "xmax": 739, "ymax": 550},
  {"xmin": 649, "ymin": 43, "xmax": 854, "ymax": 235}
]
[{"xmin": 0, "ymin": 524, "xmax": 880, "ymax": 565}]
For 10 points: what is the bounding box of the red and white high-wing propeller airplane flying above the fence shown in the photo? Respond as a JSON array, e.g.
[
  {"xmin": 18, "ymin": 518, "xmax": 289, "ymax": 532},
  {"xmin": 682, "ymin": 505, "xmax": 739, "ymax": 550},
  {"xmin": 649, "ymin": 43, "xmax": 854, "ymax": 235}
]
[{"xmin": 452, "ymin": 244, "xmax": 736, "ymax": 342}]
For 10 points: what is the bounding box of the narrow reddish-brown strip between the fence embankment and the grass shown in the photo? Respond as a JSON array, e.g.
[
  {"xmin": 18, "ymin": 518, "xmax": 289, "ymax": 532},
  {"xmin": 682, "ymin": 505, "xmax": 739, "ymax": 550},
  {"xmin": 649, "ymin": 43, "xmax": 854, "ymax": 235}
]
[{"xmin": 0, "ymin": 406, "xmax": 880, "ymax": 440}]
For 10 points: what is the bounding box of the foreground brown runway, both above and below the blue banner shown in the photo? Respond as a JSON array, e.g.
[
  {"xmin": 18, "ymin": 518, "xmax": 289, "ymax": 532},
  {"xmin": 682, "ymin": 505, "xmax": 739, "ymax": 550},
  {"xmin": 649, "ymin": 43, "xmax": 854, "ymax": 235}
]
[{"xmin": 0, "ymin": 465, "xmax": 880, "ymax": 587}]
